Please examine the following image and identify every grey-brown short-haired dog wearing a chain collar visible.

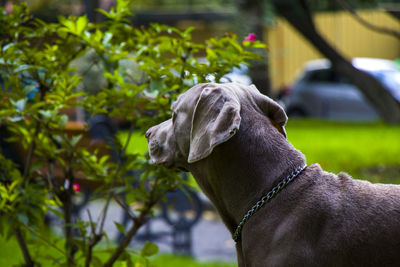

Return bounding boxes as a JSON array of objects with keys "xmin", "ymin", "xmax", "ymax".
[{"xmin": 146, "ymin": 83, "xmax": 400, "ymax": 267}]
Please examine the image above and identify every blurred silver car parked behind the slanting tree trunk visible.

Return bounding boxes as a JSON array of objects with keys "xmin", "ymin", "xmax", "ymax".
[{"xmin": 284, "ymin": 58, "xmax": 400, "ymax": 121}]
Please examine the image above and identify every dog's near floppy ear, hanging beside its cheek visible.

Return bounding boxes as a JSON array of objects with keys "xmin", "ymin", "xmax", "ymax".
[{"xmin": 188, "ymin": 87, "xmax": 241, "ymax": 163}]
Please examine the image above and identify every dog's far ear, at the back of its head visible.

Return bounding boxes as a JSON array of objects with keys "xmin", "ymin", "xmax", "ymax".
[{"xmin": 250, "ymin": 85, "xmax": 288, "ymax": 138}]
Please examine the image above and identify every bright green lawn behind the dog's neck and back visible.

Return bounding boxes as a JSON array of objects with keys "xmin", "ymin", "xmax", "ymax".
[{"xmin": 286, "ymin": 120, "xmax": 400, "ymax": 183}]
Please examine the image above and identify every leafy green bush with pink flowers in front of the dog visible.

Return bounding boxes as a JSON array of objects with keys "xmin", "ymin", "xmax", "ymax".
[{"xmin": 0, "ymin": 0, "xmax": 264, "ymax": 266}]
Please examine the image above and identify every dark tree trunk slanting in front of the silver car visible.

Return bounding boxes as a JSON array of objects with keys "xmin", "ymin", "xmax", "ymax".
[{"xmin": 273, "ymin": 0, "xmax": 400, "ymax": 124}]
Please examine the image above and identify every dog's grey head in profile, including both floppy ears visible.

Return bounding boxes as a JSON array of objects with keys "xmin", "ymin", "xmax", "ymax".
[{"xmin": 146, "ymin": 83, "xmax": 287, "ymax": 168}]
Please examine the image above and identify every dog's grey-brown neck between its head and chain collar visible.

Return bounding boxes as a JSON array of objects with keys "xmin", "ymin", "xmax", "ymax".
[{"xmin": 189, "ymin": 114, "xmax": 305, "ymax": 236}]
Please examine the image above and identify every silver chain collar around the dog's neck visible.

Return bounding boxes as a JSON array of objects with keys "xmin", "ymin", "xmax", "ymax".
[{"xmin": 232, "ymin": 165, "xmax": 307, "ymax": 242}]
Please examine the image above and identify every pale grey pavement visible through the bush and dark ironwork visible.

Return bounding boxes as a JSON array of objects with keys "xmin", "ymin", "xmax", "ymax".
[{"xmin": 81, "ymin": 201, "xmax": 236, "ymax": 262}]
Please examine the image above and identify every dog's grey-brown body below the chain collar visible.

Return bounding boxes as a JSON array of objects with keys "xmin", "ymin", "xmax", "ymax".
[{"xmin": 243, "ymin": 164, "xmax": 400, "ymax": 266}]
